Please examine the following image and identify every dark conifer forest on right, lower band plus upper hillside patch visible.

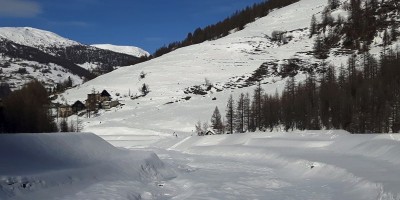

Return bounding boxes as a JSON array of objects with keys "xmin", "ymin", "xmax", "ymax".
[{"xmin": 203, "ymin": 0, "xmax": 400, "ymax": 135}]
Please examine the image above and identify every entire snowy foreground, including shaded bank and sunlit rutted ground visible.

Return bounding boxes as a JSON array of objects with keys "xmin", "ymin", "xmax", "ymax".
[{"xmin": 0, "ymin": 131, "xmax": 400, "ymax": 200}]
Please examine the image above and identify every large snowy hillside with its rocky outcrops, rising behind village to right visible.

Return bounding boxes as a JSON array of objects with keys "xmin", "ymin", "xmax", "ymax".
[{"xmin": 60, "ymin": 0, "xmax": 399, "ymax": 133}]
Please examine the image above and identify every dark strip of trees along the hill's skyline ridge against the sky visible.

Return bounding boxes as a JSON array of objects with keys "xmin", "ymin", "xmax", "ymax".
[{"xmin": 153, "ymin": 0, "xmax": 299, "ymax": 57}]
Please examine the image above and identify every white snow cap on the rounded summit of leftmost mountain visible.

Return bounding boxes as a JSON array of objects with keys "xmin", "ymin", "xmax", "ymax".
[{"xmin": 0, "ymin": 27, "xmax": 81, "ymax": 49}]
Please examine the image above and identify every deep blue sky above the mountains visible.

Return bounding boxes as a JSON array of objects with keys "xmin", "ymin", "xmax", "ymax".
[{"xmin": 0, "ymin": 0, "xmax": 263, "ymax": 53}]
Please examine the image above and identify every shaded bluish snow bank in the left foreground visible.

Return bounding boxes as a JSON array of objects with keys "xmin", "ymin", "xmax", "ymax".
[{"xmin": 0, "ymin": 133, "xmax": 174, "ymax": 199}]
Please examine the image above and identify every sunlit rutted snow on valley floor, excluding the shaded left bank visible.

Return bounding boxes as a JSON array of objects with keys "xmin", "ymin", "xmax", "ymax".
[{"xmin": 3, "ymin": 131, "xmax": 400, "ymax": 200}]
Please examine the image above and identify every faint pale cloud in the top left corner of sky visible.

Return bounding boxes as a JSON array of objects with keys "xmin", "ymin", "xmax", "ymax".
[{"xmin": 0, "ymin": 0, "xmax": 42, "ymax": 18}]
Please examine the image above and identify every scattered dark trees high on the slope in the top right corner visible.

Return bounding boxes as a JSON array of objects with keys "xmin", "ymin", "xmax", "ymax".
[{"xmin": 309, "ymin": 0, "xmax": 400, "ymax": 54}]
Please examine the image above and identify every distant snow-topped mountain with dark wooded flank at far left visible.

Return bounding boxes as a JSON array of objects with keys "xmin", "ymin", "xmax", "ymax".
[{"xmin": 0, "ymin": 27, "xmax": 143, "ymax": 88}]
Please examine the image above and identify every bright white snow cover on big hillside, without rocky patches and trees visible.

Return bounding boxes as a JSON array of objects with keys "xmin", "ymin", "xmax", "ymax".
[{"xmin": 54, "ymin": 0, "xmax": 330, "ymax": 134}]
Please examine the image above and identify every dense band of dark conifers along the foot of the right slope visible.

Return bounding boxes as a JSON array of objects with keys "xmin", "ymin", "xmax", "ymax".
[{"xmin": 200, "ymin": 50, "xmax": 400, "ymax": 135}]
